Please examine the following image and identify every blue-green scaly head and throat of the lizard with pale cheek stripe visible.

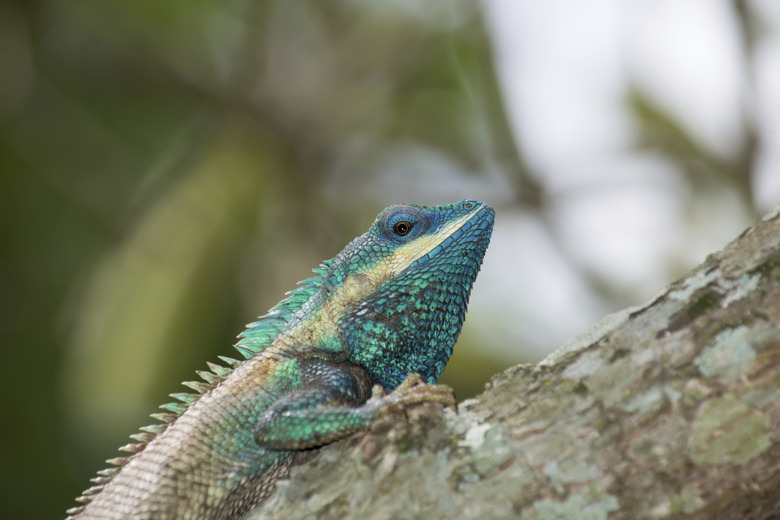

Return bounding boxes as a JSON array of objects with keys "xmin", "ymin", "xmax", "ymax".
[{"xmin": 334, "ymin": 200, "xmax": 495, "ymax": 390}]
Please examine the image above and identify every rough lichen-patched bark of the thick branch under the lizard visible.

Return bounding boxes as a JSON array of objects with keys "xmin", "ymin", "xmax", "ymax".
[{"xmin": 249, "ymin": 206, "xmax": 780, "ymax": 519}]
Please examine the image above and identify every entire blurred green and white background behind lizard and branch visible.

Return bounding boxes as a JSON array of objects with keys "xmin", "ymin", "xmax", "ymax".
[{"xmin": 0, "ymin": 0, "xmax": 780, "ymax": 519}]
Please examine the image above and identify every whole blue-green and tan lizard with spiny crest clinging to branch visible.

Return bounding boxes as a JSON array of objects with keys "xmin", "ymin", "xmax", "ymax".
[{"xmin": 67, "ymin": 200, "xmax": 495, "ymax": 520}]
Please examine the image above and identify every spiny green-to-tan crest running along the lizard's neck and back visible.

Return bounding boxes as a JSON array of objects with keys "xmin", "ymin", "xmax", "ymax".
[{"xmin": 66, "ymin": 260, "xmax": 333, "ymax": 520}]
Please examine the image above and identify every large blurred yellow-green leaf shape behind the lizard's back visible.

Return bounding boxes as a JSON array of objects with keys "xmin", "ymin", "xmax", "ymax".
[{"xmin": 65, "ymin": 119, "xmax": 279, "ymax": 480}]
